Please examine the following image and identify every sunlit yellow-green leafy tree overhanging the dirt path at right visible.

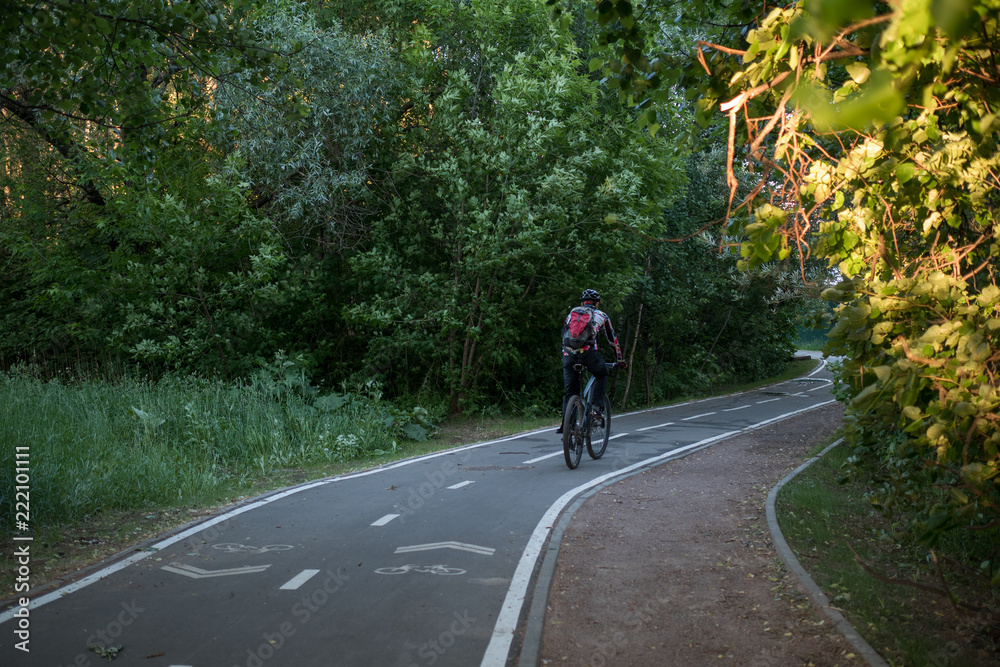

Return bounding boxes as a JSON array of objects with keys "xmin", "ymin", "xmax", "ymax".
[{"xmin": 572, "ymin": 0, "xmax": 1000, "ymax": 544}]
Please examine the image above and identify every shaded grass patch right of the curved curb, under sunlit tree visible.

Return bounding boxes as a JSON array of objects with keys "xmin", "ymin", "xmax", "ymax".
[{"xmin": 777, "ymin": 445, "xmax": 1000, "ymax": 667}]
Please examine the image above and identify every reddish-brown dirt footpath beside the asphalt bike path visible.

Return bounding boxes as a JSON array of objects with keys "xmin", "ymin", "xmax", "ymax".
[{"xmin": 539, "ymin": 404, "xmax": 864, "ymax": 667}]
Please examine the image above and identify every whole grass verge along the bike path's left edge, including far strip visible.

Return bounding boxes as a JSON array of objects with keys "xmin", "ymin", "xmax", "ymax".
[{"xmin": 0, "ymin": 360, "xmax": 816, "ymax": 599}]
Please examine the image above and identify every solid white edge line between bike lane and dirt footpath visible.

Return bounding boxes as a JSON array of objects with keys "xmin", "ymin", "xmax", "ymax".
[{"xmin": 480, "ymin": 399, "xmax": 836, "ymax": 667}]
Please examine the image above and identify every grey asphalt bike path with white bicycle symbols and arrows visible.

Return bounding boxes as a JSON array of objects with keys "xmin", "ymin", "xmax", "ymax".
[{"xmin": 0, "ymin": 360, "xmax": 833, "ymax": 667}]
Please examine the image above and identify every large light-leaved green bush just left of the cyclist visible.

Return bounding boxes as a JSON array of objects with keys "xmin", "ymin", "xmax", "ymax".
[{"xmin": 349, "ymin": 9, "xmax": 675, "ymax": 411}]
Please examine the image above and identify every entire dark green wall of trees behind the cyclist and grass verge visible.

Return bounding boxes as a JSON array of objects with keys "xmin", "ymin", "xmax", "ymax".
[{"xmin": 0, "ymin": 0, "xmax": 812, "ymax": 486}]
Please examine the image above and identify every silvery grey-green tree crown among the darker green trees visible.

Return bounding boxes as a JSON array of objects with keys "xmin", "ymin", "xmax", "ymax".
[{"xmin": 215, "ymin": 7, "xmax": 402, "ymax": 245}]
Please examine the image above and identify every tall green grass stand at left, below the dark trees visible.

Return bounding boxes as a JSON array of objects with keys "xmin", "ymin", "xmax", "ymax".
[{"xmin": 0, "ymin": 371, "xmax": 429, "ymax": 539}]
